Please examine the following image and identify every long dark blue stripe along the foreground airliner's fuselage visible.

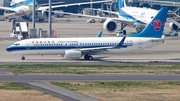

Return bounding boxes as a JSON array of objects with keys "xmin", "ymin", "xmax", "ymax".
[{"xmin": 6, "ymin": 44, "xmax": 133, "ymax": 52}]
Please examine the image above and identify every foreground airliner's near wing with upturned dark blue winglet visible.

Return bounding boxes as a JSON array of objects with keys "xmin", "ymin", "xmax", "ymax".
[{"xmin": 80, "ymin": 36, "xmax": 126, "ymax": 55}]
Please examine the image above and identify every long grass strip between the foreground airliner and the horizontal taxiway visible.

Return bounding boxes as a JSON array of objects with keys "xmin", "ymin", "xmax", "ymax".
[{"xmin": 0, "ymin": 64, "xmax": 180, "ymax": 74}]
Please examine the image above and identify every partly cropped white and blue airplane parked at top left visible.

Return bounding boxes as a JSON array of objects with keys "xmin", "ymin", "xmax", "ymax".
[{"xmin": 0, "ymin": 0, "xmax": 111, "ymax": 19}]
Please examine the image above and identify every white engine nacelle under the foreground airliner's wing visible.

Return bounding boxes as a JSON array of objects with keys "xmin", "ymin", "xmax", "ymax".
[{"xmin": 65, "ymin": 50, "xmax": 82, "ymax": 59}]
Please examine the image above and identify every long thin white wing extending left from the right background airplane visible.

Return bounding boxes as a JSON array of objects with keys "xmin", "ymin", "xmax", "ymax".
[{"xmin": 61, "ymin": 12, "xmax": 134, "ymax": 25}]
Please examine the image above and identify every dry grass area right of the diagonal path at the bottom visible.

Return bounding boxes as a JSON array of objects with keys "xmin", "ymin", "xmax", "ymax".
[{"xmin": 50, "ymin": 82, "xmax": 180, "ymax": 101}]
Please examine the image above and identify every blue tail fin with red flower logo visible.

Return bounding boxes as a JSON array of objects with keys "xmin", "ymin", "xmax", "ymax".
[{"xmin": 130, "ymin": 7, "xmax": 168, "ymax": 38}]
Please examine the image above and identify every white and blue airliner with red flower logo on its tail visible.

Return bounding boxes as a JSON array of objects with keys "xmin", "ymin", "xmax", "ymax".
[{"xmin": 6, "ymin": 7, "xmax": 168, "ymax": 60}]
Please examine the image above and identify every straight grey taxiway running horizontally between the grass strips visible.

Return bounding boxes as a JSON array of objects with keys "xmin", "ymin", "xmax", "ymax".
[{"xmin": 0, "ymin": 74, "xmax": 180, "ymax": 82}]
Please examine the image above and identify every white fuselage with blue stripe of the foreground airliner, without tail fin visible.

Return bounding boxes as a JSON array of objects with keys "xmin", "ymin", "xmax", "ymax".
[{"xmin": 6, "ymin": 37, "xmax": 162, "ymax": 56}]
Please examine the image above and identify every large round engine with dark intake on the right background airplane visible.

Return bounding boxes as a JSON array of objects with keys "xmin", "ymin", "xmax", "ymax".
[{"xmin": 103, "ymin": 19, "xmax": 117, "ymax": 33}]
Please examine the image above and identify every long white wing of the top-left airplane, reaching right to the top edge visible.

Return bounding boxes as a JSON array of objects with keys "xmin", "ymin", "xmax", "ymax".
[{"xmin": 37, "ymin": 0, "xmax": 112, "ymax": 10}]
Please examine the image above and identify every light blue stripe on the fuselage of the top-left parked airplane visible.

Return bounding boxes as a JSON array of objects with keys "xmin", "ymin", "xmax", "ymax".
[{"xmin": 11, "ymin": 0, "xmax": 38, "ymax": 9}]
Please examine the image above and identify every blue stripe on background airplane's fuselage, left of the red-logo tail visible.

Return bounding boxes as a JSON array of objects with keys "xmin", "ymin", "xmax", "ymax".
[{"xmin": 119, "ymin": 9, "xmax": 147, "ymax": 24}]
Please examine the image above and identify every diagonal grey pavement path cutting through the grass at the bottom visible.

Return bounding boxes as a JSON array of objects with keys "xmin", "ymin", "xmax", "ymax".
[{"xmin": 18, "ymin": 82, "xmax": 99, "ymax": 101}]
